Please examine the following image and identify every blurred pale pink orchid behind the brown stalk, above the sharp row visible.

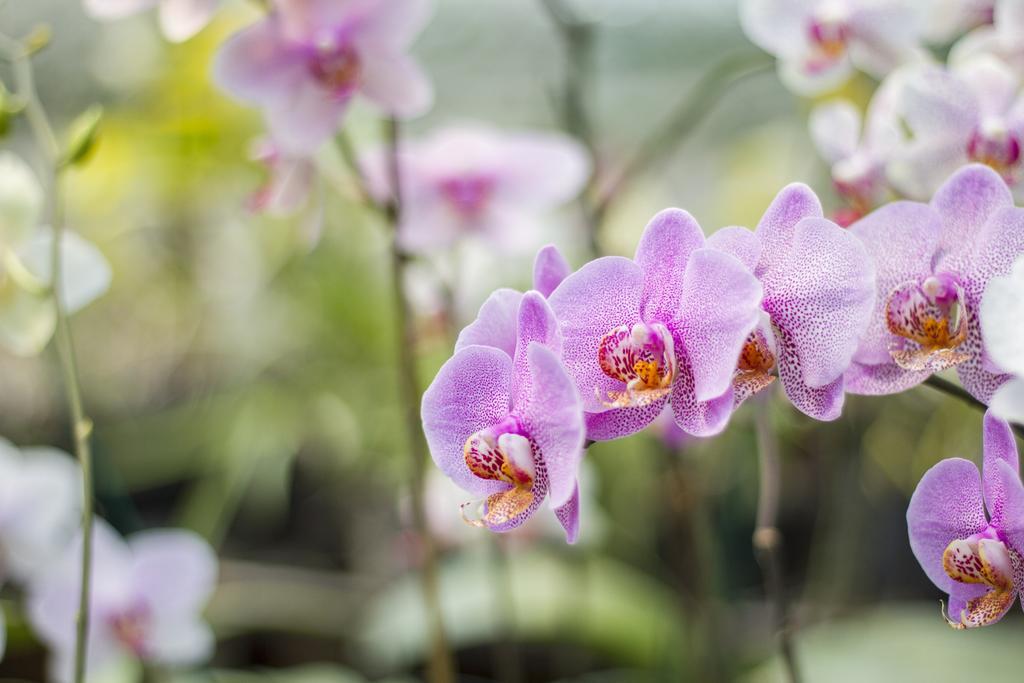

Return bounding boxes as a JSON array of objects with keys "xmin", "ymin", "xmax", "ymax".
[{"xmin": 361, "ymin": 124, "xmax": 590, "ymax": 251}]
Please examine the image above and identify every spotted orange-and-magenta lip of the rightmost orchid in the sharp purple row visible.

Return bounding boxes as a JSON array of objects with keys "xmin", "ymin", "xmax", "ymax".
[{"xmin": 886, "ymin": 273, "xmax": 970, "ymax": 372}]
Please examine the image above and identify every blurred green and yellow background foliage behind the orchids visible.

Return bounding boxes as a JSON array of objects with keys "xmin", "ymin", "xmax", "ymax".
[{"xmin": 0, "ymin": 0, "xmax": 1024, "ymax": 683}]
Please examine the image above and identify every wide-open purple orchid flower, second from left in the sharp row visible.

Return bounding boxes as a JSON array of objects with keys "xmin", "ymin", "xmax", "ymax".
[{"xmin": 550, "ymin": 209, "xmax": 761, "ymax": 440}]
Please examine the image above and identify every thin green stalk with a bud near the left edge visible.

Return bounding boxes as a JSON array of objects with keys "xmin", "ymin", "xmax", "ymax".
[{"xmin": 0, "ymin": 29, "xmax": 93, "ymax": 683}]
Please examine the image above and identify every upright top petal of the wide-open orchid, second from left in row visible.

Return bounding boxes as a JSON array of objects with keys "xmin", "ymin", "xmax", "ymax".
[{"xmin": 634, "ymin": 209, "xmax": 705, "ymax": 323}]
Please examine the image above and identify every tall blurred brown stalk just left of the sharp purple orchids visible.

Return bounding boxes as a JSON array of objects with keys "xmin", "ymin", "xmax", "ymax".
[{"xmin": 384, "ymin": 119, "xmax": 455, "ymax": 683}]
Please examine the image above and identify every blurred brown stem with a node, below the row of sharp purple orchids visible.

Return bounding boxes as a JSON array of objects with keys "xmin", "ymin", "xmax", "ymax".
[{"xmin": 753, "ymin": 398, "xmax": 801, "ymax": 683}]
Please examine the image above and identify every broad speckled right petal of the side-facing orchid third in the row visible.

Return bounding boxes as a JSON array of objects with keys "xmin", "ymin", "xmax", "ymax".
[{"xmin": 758, "ymin": 218, "xmax": 874, "ymax": 393}]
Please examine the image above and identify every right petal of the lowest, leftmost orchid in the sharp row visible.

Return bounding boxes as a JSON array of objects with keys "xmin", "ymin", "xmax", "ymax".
[{"xmin": 517, "ymin": 342, "xmax": 586, "ymax": 508}]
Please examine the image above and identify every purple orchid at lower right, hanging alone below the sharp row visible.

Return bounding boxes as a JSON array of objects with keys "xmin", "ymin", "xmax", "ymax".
[{"xmin": 906, "ymin": 414, "xmax": 1024, "ymax": 629}]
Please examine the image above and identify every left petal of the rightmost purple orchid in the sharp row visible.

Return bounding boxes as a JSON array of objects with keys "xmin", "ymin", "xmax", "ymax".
[{"xmin": 849, "ymin": 202, "xmax": 942, "ymax": 365}]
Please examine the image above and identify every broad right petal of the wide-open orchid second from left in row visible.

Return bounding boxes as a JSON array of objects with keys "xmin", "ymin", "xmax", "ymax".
[{"xmin": 679, "ymin": 248, "xmax": 762, "ymax": 401}]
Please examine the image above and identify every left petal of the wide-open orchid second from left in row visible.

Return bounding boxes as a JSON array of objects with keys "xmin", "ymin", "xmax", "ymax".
[{"xmin": 548, "ymin": 256, "xmax": 643, "ymax": 413}]
